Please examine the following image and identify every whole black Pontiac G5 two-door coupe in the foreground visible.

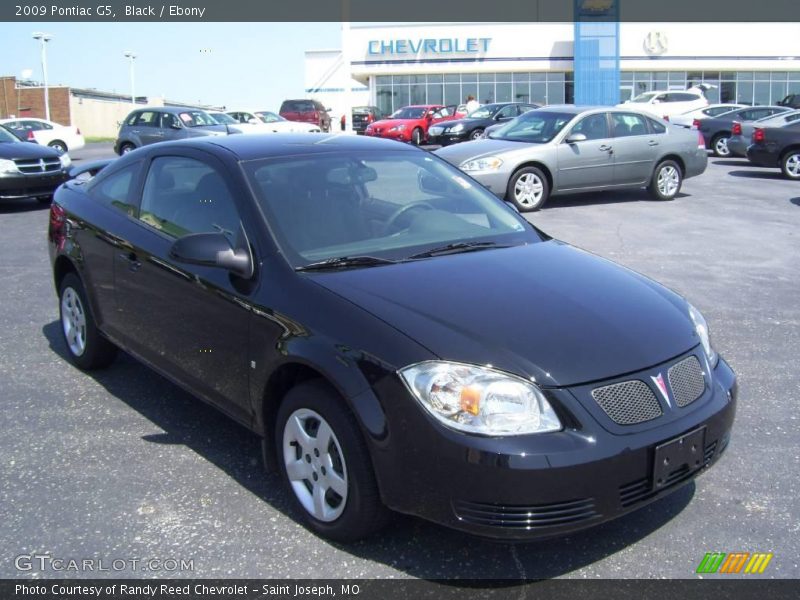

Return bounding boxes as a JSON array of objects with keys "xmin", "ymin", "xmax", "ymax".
[{"xmin": 49, "ymin": 135, "xmax": 736, "ymax": 541}]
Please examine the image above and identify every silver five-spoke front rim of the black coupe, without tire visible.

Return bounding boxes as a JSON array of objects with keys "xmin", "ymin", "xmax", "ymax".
[{"xmin": 283, "ymin": 408, "xmax": 347, "ymax": 522}]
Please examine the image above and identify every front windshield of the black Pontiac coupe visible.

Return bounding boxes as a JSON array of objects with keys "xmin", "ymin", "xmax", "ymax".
[{"xmin": 243, "ymin": 150, "xmax": 541, "ymax": 268}]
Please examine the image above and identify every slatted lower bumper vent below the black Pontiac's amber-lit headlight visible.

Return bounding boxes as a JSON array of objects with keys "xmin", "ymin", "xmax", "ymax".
[{"xmin": 453, "ymin": 498, "xmax": 599, "ymax": 529}]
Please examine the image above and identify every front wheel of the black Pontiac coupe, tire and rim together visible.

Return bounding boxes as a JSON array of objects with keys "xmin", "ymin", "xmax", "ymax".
[{"xmin": 275, "ymin": 381, "xmax": 388, "ymax": 542}]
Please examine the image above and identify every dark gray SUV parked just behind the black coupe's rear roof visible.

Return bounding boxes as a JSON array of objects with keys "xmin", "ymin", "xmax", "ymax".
[{"xmin": 114, "ymin": 106, "xmax": 234, "ymax": 155}]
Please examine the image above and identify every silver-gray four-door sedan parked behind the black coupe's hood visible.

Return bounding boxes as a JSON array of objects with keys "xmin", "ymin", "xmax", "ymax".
[{"xmin": 436, "ymin": 105, "xmax": 708, "ymax": 211}]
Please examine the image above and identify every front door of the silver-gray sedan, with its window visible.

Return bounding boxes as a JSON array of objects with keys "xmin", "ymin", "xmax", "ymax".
[{"xmin": 554, "ymin": 112, "xmax": 614, "ymax": 191}]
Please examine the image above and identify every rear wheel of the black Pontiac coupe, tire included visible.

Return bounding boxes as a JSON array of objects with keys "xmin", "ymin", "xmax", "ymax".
[{"xmin": 58, "ymin": 273, "xmax": 117, "ymax": 370}]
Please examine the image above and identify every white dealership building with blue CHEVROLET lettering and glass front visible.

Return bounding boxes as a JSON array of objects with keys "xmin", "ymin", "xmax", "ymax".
[{"xmin": 305, "ymin": 23, "xmax": 800, "ymax": 118}]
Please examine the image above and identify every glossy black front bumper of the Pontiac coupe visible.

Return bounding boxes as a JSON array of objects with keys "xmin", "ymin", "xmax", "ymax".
[{"xmin": 373, "ymin": 353, "xmax": 737, "ymax": 539}]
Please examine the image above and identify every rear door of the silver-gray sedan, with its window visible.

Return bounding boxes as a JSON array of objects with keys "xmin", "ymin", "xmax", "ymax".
[{"xmin": 611, "ymin": 112, "xmax": 664, "ymax": 185}]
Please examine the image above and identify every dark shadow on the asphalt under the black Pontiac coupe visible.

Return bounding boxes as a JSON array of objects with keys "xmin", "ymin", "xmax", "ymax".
[{"xmin": 42, "ymin": 321, "xmax": 695, "ymax": 587}]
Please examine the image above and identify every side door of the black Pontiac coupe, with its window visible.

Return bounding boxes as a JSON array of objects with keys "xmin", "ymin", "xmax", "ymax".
[{"xmin": 114, "ymin": 148, "xmax": 253, "ymax": 421}]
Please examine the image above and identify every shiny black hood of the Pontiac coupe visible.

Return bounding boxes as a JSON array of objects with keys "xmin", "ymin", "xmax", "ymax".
[{"xmin": 311, "ymin": 241, "xmax": 699, "ymax": 386}]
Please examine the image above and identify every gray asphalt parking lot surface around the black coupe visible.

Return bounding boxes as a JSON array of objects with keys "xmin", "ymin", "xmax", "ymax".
[{"xmin": 0, "ymin": 144, "xmax": 800, "ymax": 579}]
